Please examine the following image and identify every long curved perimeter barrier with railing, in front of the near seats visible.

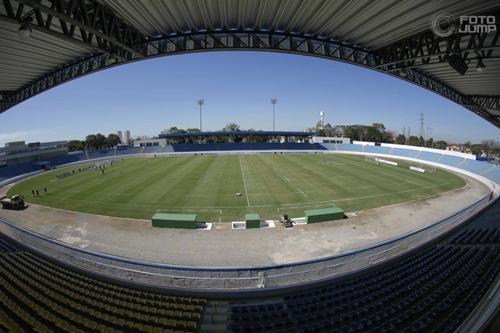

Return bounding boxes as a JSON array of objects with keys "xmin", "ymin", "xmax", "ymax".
[{"xmin": 0, "ymin": 191, "xmax": 492, "ymax": 294}]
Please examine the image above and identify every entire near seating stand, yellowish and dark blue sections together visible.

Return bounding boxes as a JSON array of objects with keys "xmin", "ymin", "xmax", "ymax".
[{"xmin": 0, "ymin": 197, "xmax": 500, "ymax": 333}]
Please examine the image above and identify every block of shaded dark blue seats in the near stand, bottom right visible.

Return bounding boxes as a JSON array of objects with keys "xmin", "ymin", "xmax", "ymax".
[{"xmin": 229, "ymin": 197, "xmax": 500, "ymax": 332}]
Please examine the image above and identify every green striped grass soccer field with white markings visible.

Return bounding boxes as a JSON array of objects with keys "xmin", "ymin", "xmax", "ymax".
[{"xmin": 9, "ymin": 154, "xmax": 465, "ymax": 221}]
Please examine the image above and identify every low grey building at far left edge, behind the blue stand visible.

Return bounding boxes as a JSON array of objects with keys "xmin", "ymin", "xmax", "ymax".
[{"xmin": 0, "ymin": 141, "xmax": 68, "ymax": 165}]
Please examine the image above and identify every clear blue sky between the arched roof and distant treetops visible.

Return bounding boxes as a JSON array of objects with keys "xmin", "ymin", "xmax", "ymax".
[{"xmin": 0, "ymin": 51, "xmax": 500, "ymax": 145}]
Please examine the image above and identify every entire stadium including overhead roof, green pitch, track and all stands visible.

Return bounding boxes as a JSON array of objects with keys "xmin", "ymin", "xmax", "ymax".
[{"xmin": 0, "ymin": 0, "xmax": 500, "ymax": 333}]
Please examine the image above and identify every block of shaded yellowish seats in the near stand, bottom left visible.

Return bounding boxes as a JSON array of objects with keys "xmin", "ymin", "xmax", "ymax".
[{"xmin": 0, "ymin": 235, "xmax": 206, "ymax": 333}]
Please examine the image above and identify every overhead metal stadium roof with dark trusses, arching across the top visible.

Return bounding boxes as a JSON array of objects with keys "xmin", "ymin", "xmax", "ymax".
[{"xmin": 0, "ymin": 0, "xmax": 500, "ymax": 127}]
